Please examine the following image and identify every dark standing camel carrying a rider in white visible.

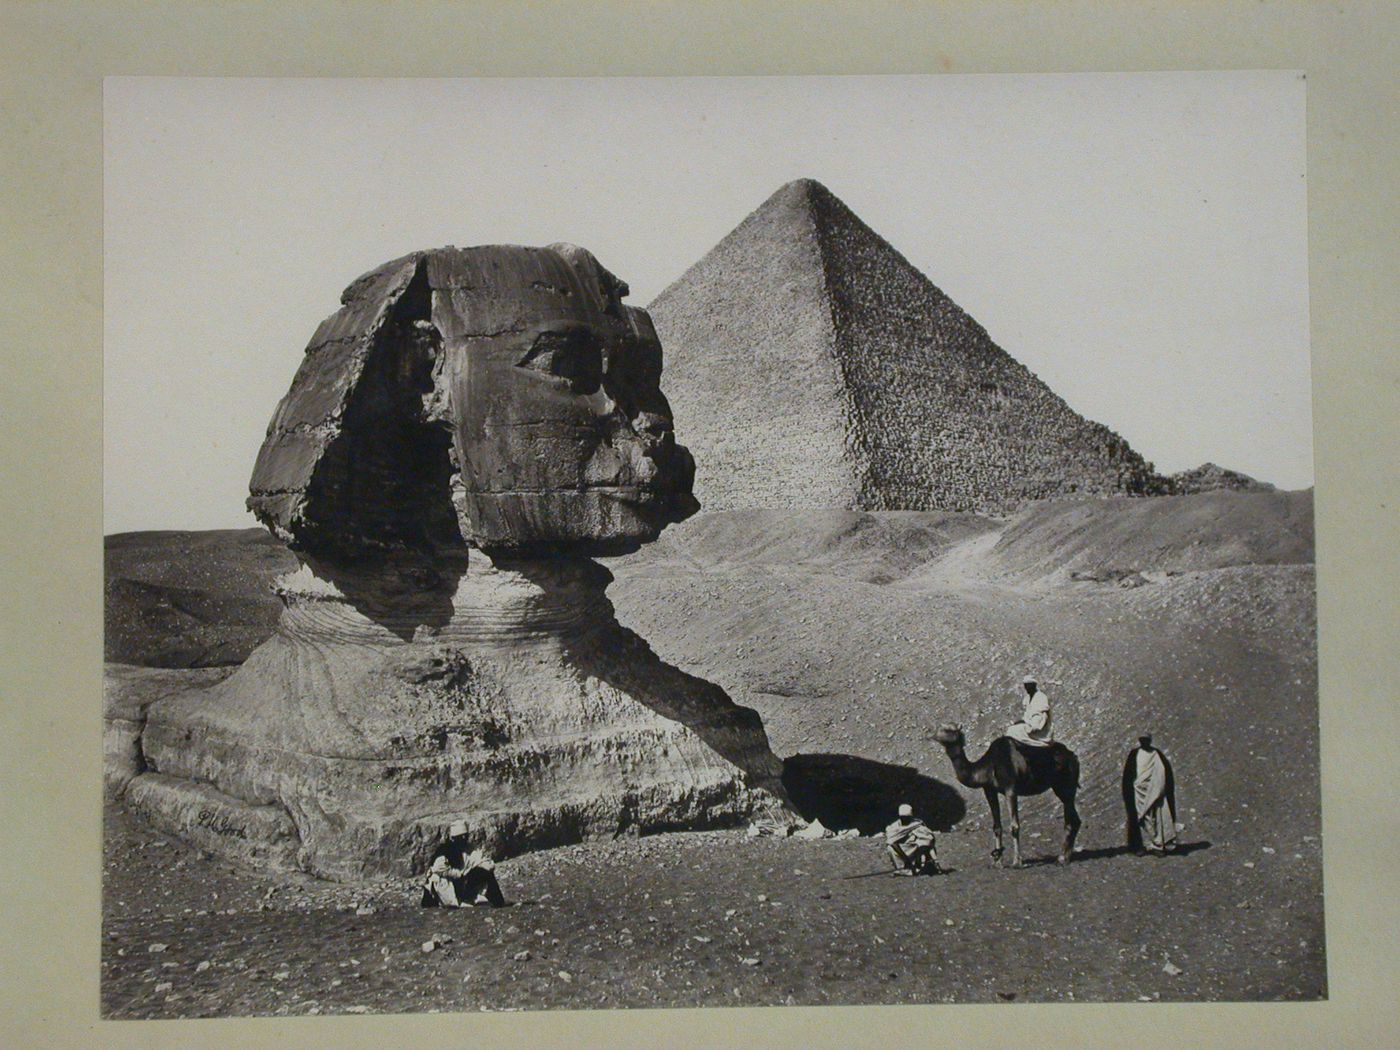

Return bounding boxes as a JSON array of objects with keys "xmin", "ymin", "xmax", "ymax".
[{"xmin": 934, "ymin": 725, "xmax": 1079, "ymax": 868}]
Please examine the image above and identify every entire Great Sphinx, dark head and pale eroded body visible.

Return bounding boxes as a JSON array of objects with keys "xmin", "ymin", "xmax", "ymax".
[{"xmin": 109, "ymin": 244, "xmax": 788, "ymax": 879}]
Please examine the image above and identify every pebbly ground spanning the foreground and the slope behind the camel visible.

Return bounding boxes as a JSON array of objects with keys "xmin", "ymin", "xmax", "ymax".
[{"xmin": 102, "ymin": 493, "xmax": 1326, "ymax": 1016}]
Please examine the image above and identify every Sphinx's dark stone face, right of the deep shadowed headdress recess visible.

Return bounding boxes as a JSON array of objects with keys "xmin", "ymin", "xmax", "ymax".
[{"xmin": 428, "ymin": 245, "xmax": 699, "ymax": 553}]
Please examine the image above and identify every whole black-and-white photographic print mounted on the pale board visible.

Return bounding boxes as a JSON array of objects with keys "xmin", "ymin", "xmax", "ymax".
[{"xmin": 94, "ymin": 70, "xmax": 1327, "ymax": 1019}]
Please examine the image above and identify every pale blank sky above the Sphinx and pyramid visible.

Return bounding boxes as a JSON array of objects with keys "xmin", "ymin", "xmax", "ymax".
[{"xmin": 104, "ymin": 71, "xmax": 1313, "ymax": 532}]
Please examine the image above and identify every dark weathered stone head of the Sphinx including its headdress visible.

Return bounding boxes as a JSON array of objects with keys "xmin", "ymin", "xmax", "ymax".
[{"xmin": 248, "ymin": 245, "xmax": 699, "ymax": 561}]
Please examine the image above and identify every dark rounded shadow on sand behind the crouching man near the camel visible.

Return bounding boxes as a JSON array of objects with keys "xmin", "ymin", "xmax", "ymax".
[{"xmin": 783, "ymin": 755, "xmax": 966, "ymax": 834}]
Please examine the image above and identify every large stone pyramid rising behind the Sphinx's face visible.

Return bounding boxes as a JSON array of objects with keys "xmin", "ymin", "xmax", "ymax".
[{"xmin": 648, "ymin": 179, "xmax": 1162, "ymax": 512}]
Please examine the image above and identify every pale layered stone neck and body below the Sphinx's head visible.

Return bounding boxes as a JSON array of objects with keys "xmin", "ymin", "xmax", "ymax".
[{"xmin": 127, "ymin": 557, "xmax": 783, "ymax": 879}]
